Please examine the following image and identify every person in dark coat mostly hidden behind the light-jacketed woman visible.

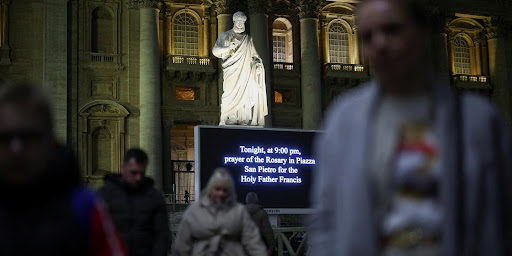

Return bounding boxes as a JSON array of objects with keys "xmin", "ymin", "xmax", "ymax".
[{"xmin": 245, "ymin": 192, "xmax": 276, "ymax": 255}]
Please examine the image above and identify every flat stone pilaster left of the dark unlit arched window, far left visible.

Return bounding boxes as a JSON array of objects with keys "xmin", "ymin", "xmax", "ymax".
[{"xmin": 43, "ymin": 0, "xmax": 68, "ymax": 143}]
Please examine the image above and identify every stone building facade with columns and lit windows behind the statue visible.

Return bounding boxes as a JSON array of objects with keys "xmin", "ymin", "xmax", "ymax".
[{"xmin": 0, "ymin": 0, "xmax": 512, "ymax": 194}]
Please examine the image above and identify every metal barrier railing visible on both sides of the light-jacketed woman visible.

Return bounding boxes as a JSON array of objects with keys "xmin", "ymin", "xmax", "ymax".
[{"xmin": 171, "ymin": 227, "xmax": 310, "ymax": 256}]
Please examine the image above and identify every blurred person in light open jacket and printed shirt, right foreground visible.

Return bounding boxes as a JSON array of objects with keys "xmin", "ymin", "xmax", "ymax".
[{"xmin": 310, "ymin": 0, "xmax": 512, "ymax": 256}]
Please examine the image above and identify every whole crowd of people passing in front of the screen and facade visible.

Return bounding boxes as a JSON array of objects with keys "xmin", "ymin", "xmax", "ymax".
[{"xmin": 0, "ymin": 0, "xmax": 512, "ymax": 256}]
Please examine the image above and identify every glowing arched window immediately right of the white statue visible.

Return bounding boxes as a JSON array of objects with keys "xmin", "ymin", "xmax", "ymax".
[{"xmin": 272, "ymin": 18, "xmax": 293, "ymax": 63}]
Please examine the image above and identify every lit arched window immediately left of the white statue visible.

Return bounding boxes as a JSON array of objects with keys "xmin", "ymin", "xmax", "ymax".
[{"xmin": 173, "ymin": 13, "xmax": 199, "ymax": 56}]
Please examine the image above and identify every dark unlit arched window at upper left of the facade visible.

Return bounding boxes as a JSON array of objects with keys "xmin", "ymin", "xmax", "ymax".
[{"xmin": 91, "ymin": 7, "xmax": 114, "ymax": 53}]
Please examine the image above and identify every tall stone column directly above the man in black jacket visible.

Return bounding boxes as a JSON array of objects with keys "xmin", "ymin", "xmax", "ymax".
[{"xmin": 139, "ymin": 0, "xmax": 163, "ymax": 189}]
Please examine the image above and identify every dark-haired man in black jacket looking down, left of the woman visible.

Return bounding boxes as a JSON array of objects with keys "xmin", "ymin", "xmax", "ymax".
[{"xmin": 99, "ymin": 148, "xmax": 170, "ymax": 256}]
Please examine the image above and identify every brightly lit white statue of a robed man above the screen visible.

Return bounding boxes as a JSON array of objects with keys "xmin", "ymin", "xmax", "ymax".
[{"xmin": 213, "ymin": 12, "xmax": 268, "ymax": 126}]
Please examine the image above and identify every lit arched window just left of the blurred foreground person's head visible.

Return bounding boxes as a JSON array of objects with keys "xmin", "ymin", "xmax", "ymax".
[{"xmin": 329, "ymin": 22, "xmax": 349, "ymax": 64}]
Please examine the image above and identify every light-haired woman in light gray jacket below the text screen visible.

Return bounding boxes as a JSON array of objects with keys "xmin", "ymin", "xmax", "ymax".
[{"xmin": 174, "ymin": 168, "xmax": 267, "ymax": 256}]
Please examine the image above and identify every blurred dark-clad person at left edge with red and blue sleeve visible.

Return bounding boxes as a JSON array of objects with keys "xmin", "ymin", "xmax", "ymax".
[{"xmin": 0, "ymin": 83, "xmax": 126, "ymax": 256}]
